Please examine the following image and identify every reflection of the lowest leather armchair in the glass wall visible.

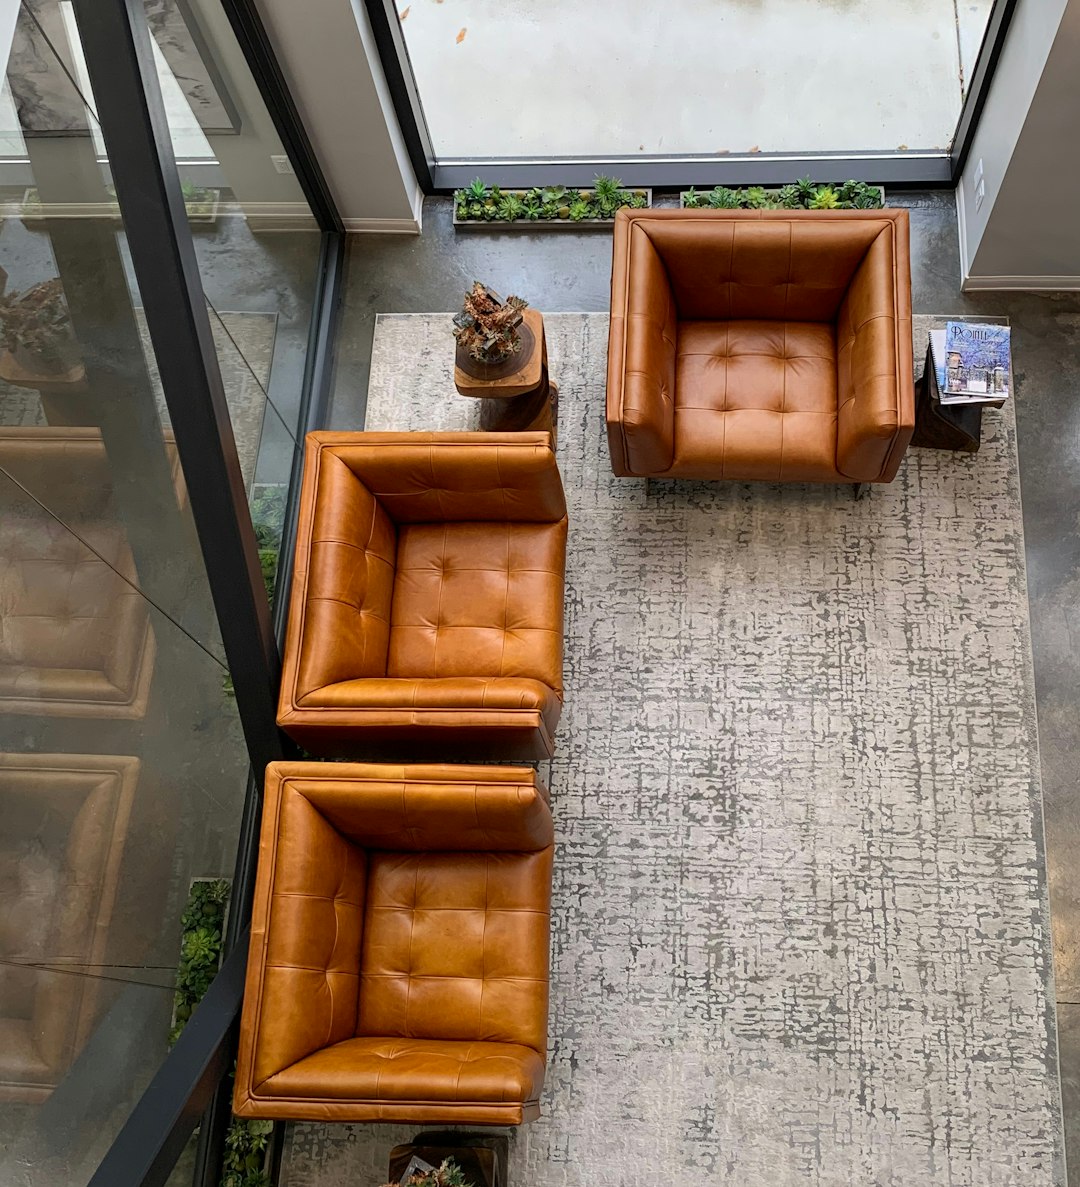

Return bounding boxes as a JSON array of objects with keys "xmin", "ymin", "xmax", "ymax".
[{"xmin": 0, "ymin": 754, "xmax": 139, "ymax": 1102}]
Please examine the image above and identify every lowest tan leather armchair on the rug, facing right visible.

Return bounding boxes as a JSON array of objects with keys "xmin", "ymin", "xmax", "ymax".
[{"xmin": 234, "ymin": 763, "xmax": 553, "ymax": 1125}]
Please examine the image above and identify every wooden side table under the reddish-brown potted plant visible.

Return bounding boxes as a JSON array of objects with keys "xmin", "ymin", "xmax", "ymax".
[{"xmin": 453, "ymin": 309, "xmax": 559, "ymax": 440}]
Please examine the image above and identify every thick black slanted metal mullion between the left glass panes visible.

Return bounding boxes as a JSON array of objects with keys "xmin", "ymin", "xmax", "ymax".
[{"xmin": 74, "ymin": 0, "xmax": 293, "ymax": 773}]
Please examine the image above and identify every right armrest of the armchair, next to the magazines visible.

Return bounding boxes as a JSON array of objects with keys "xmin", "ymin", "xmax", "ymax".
[{"xmin": 837, "ymin": 211, "xmax": 915, "ymax": 482}]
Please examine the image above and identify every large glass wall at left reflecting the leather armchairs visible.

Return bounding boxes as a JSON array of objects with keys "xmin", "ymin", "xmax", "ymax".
[{"xmin": 0, "ymin": 0, "xmax": 319, "ymax": 1187}]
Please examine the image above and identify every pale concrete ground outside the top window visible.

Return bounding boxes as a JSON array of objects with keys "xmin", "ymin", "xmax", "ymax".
[{"xmin": 398, "ymin": 0, "xmax": 991, "ymax": 159}]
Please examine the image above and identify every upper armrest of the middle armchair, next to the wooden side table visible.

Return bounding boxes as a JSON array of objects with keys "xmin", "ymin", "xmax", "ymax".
[{"xmin": 309, "ymin": 432, "xmax": 566, "ymax": 523}]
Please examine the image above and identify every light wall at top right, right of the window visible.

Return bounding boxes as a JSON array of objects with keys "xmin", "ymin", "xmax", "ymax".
[{"xmin": 957, "ymin": 0, "xmax": 1080, "ymax": 290}]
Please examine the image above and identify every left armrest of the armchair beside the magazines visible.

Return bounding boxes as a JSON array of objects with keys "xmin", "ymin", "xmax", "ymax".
[{"xmin": 606, "ymin": 211, "xmax": 678, "ymax": 476}]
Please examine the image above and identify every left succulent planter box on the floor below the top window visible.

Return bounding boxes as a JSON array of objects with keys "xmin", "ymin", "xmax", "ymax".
[{"xmin": 453, "ymin": 176, "xmax": 653, "ymax": 230}]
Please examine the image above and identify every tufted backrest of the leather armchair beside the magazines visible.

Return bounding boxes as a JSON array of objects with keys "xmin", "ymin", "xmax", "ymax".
[{"xmin": 634, "ymin": 211, "xmax": 889, "ymax": 322}]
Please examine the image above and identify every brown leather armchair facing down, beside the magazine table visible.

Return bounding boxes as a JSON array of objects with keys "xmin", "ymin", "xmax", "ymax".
[{"xmin": 608, "ymin": 210, "xmax": 915, "ymax": 483}]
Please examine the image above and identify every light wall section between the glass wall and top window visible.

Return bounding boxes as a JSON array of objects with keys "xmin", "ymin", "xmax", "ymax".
[{"xmin": 258, "ymin": 0, "xmax": 423, "ymax": 231}]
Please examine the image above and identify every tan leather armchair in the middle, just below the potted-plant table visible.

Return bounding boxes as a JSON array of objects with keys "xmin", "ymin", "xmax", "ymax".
[{"xmin": 278, "ymin": 432, "xmax": 566, "ymax": 758}]
